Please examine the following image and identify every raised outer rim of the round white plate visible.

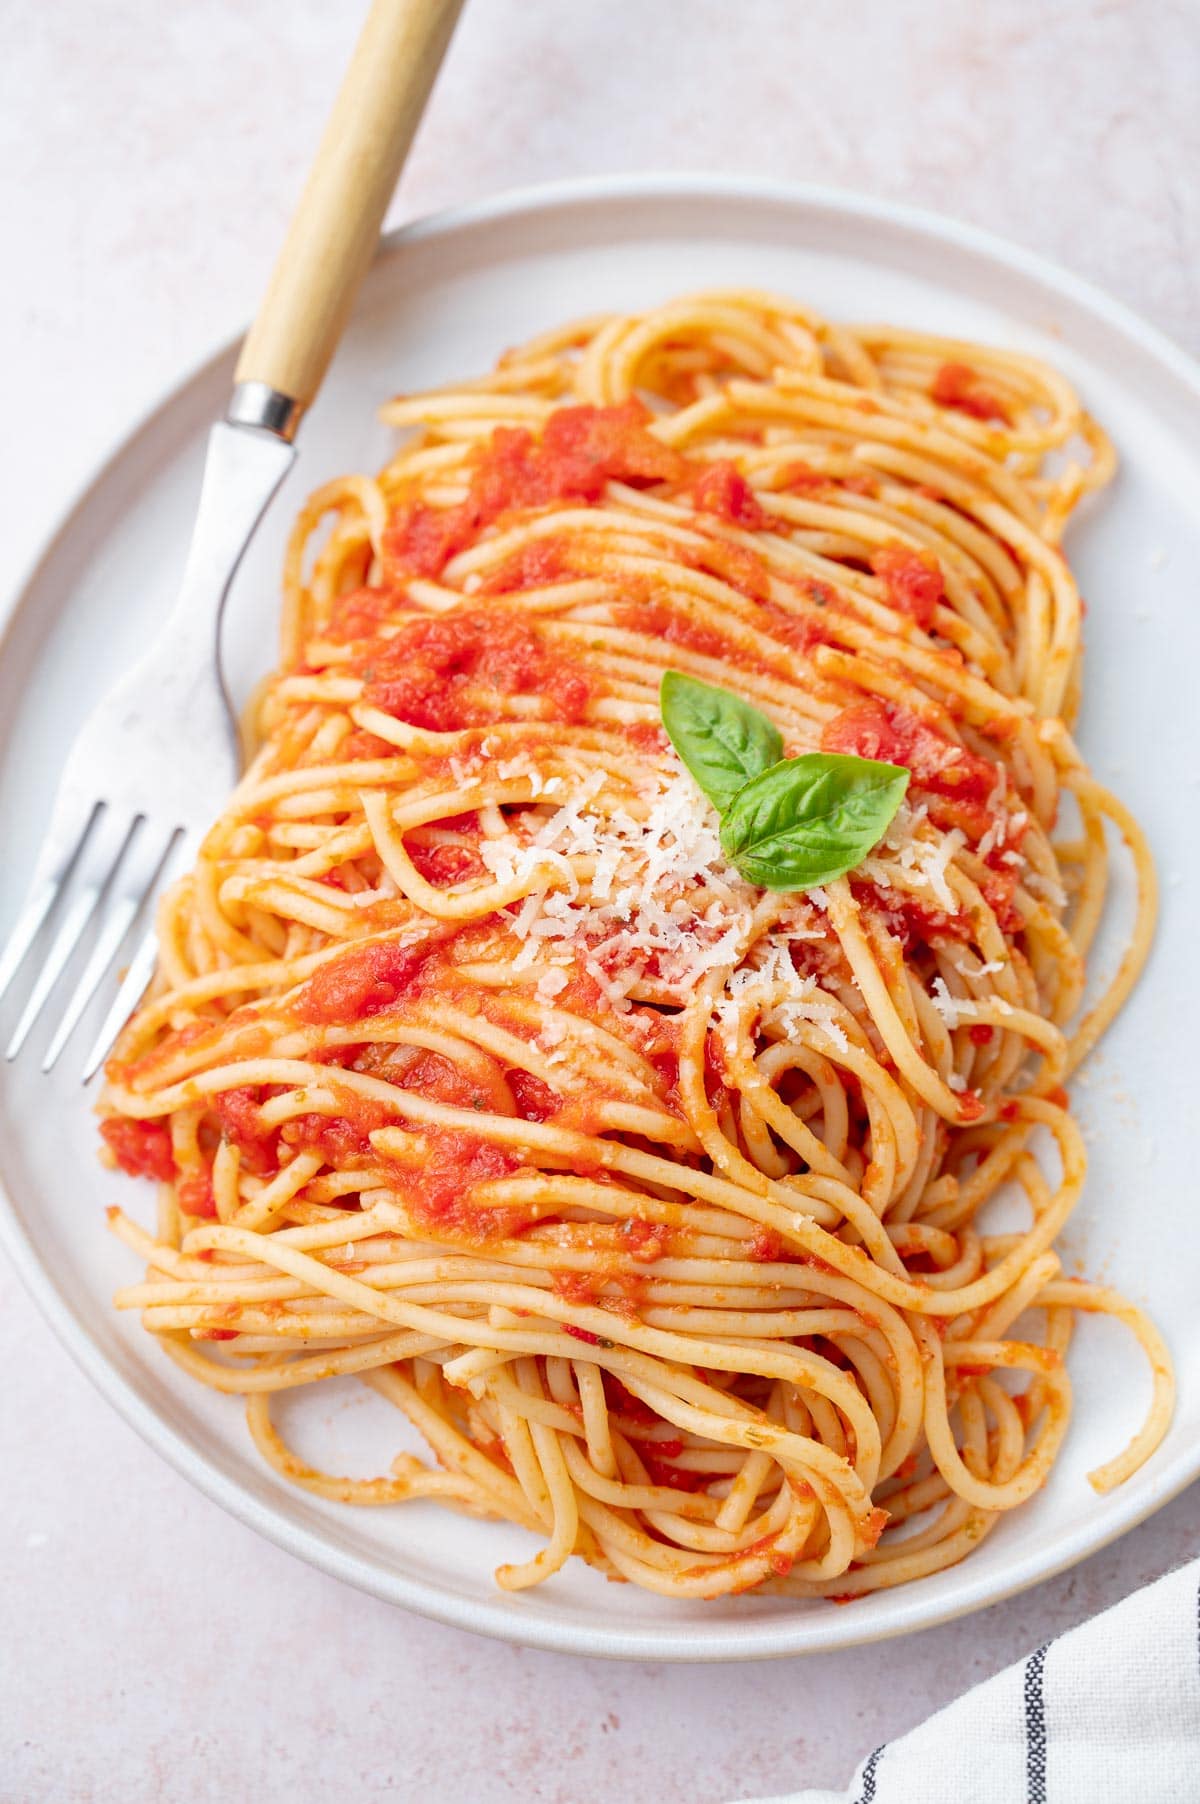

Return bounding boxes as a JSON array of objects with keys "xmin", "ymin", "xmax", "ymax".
[{"xmin": 0, "ymin": 171, "xmax": 1200, "ymax": 1663}]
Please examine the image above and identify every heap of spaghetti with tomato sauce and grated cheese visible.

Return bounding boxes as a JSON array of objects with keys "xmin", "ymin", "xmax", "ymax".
[{"xmin": 101, "ymin": 290, "xmax": 1171, "ymax": 1598}]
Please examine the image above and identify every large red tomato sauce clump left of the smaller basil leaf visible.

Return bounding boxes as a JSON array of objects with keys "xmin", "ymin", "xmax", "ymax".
[{"xmin": 361, "ymin": 608, "xmax": 597, "ymax": 732}]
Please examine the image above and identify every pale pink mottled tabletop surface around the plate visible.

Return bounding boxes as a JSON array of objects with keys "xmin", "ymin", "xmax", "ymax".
[{"xmin": 0, "ymin": 0, "xmax": 1200, "ymax": 1804}]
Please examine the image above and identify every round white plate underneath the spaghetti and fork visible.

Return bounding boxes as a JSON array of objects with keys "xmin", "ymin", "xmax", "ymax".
[{"xmin": 0, "ymin": 179, "xmax": 1200, "ymax": 1660}]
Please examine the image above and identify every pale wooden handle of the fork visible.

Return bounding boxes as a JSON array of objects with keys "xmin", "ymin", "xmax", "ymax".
[{"xmin": 235, "ymin": 0, "xmax": 464, "ymax": 422}]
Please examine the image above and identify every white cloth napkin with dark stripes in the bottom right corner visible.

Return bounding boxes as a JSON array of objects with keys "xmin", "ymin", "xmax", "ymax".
[{"xmin": 729, "ymin": 1560, "xmax": 1200, "ymax": 1804}]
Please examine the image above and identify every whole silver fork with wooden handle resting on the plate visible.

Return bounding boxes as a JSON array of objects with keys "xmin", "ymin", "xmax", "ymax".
[{"xmin": 0, "ymin": 0, "xmax": 464, "ymax": 1082}]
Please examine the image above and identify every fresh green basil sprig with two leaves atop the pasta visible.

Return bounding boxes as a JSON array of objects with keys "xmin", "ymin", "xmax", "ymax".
[{"xmin": 662, "ymin": 671, "xmax": 909, "ymax": 891}]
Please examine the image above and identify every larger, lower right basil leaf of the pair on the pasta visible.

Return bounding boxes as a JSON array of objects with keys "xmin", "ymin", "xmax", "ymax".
[{"xmin": 720, "ymin": 752, "xmax": 909, "ymax": 889}]
